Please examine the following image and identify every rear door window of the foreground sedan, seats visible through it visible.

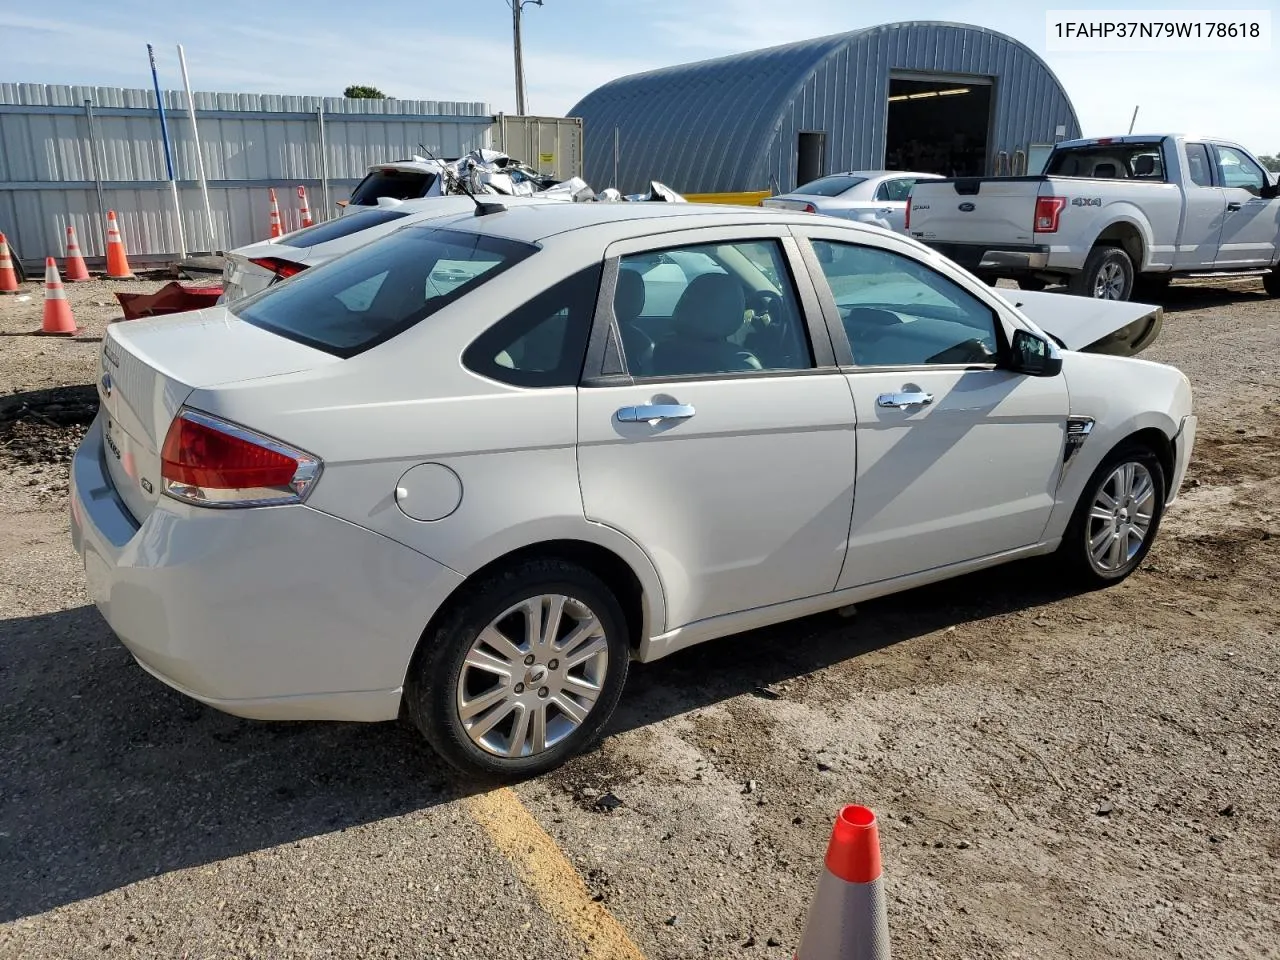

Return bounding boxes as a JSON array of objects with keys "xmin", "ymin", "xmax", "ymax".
[{"xmin": 613, "ymin": 239, "xmax": 813, "ymax": 378}]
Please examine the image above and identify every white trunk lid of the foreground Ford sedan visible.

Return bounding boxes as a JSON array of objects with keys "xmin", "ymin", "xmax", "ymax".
[{"xmin": 97, "ymin": 307, "xmax": 342, "ymax": 524}]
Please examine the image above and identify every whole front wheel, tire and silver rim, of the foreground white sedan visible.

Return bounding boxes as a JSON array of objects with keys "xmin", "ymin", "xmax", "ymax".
[{"xmin": 1059, "ymin": 443, "xmax": 1166, "ymax": 586}]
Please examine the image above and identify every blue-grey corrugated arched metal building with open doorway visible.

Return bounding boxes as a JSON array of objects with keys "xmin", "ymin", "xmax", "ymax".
[{"xmin": 568, "ymin": 22, "xmax": 1080, "ymax": 193}]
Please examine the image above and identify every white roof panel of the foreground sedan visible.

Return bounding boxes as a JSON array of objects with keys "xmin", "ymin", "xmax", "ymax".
[{"xmin": 404, "ymin": 197, "xmax": 881, "ymax": 243}]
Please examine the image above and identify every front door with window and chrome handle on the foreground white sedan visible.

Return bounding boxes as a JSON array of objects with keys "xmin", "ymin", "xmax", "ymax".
[{"xmin": 804, "ymin": 228, "xmax": 1068, "ymax": 589}]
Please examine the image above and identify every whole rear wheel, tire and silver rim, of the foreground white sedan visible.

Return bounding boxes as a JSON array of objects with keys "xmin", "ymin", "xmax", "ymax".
[{"xmin": 404, "ymin": 559, "xmax": 630, "ymax": 780}]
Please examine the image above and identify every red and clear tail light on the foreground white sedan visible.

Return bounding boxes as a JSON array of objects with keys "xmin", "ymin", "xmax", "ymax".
[{"xmin": 160, "ymin": 408, "xmax": 321, "ymax": 507}]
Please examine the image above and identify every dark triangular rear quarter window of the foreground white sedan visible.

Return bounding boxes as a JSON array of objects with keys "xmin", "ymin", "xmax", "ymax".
[{"xmin": 462, "ymin": 264, "xmax": 602, "ymax": 387}]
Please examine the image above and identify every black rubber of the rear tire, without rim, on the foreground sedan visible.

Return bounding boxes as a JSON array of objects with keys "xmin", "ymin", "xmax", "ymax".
[{"xmin": 404, "ymin": 559, "xmax": 631, "ymax": 780}]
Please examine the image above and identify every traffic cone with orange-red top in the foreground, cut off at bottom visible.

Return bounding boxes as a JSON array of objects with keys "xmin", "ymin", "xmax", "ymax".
[{"xmin": 795, "ymin": 806, "xmax": 890, "ymax": 960}]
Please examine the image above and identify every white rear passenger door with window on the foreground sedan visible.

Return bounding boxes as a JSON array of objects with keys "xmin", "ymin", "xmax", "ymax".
[{"xmin": 579, "ymin": 225, "xmax": 855, "ymax": 630}]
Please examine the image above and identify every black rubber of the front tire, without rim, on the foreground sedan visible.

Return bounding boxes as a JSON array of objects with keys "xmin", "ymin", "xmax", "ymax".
[{"xmin": 1057, "ymin": 443, "xmax": 1167, "ymax": 586}]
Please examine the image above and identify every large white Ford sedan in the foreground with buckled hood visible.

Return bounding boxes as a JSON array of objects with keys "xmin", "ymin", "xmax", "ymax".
[{"xmin": 70, "ymin": 204, "xmax": 1196, "ymax": 776}]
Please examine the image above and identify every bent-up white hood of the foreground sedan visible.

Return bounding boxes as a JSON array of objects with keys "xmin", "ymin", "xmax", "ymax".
[{"xmin": 992, "ymin": 288, "xmax": 1165, "ymax": 357}]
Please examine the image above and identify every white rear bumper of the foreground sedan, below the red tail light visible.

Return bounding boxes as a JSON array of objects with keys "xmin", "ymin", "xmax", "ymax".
[{"xmin": 70, "ymin": 421, "xmax": 461, "ymax": 721}]
